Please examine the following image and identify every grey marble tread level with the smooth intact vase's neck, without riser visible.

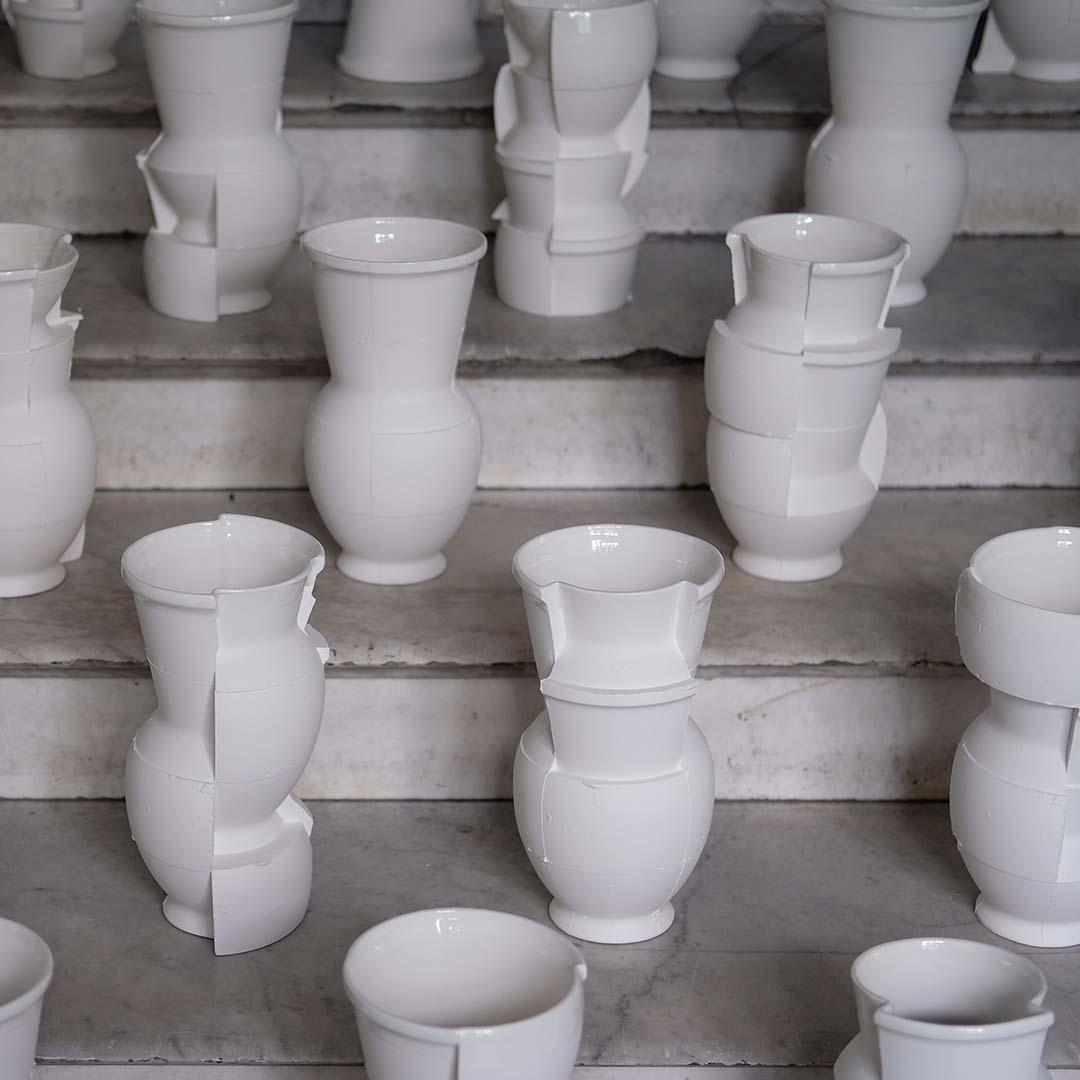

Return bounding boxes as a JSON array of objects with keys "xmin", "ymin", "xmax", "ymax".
[{"xmin": 64, "ymin": 238, "xmax": 1080, "ymax": 378}]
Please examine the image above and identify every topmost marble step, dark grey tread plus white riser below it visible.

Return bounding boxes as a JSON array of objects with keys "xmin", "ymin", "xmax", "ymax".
[{"xmin": 0, "ymin": 23, "xmax": 1080, "ymax": 234}]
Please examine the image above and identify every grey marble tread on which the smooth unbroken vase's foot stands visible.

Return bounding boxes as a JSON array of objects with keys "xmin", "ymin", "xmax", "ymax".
[{"xmin": 0, "ymin": 490, "xmax": 1080, "ymax": 675}]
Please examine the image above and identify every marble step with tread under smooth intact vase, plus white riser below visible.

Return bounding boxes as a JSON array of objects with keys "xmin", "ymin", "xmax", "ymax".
[{"xmin": 8, "ymin": 489, "xmax": 1080, "ymax": 799}]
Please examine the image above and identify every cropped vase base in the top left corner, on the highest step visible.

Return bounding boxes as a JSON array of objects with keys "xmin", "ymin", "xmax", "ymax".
[{"xmin": 3, "ymin": 0, "xmax": 133, "ymax": 79}]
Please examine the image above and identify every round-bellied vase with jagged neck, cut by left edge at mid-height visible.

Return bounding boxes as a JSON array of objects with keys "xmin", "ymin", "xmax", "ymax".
[{"xmin": 0, "ymin": 225, "xmax": 97, "ymax": 597}]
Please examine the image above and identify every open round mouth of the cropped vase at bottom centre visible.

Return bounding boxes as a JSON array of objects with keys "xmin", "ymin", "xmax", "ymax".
[{"xmin": 343, "ymin": 908, "xmax": 585, "ymax": 1042}]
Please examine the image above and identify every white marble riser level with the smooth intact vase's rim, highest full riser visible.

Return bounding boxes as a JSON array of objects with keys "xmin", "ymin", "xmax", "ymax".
[{"xmin": 4, "ymin": 126, "xmax": 1080, "ymax": 234}]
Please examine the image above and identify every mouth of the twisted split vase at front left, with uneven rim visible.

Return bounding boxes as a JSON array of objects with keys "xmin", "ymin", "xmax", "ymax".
[{"xmin": 121, "ymin": 514, "xmax": 324, "ymax": 606}]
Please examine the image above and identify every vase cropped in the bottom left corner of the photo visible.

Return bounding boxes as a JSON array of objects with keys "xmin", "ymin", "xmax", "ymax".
[{"xmin": 0, "ymin": 919, "xmax": 53, "ymax": 1080}]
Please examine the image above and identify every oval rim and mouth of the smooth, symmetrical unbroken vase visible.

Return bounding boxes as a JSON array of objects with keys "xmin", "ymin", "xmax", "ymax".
[{"xmin": 300, "ymin": 217, "xmax": 487, "ymax": 274}]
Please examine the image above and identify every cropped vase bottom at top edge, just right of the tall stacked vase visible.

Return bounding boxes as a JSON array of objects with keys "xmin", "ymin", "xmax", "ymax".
[{"xmin": 656, "ymin": 0, "xmax": 762, "ymax": 80}]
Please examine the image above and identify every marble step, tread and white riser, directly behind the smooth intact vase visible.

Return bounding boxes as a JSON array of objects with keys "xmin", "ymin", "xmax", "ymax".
[{"xmin": 65, "ymin": 238, "xmax": 1080, "ymax": 488}]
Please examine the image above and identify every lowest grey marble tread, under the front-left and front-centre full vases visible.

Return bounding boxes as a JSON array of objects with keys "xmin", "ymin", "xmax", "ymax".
[{"xmin": 6, "ymin": 801, "xmax": 1080, "ymax": 1067}]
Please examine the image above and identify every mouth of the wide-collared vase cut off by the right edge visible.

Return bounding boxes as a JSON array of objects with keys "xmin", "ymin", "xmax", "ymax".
[{"xmin": 969, "ymin": 525, "xmax": 1080, "ymax": 616}]
